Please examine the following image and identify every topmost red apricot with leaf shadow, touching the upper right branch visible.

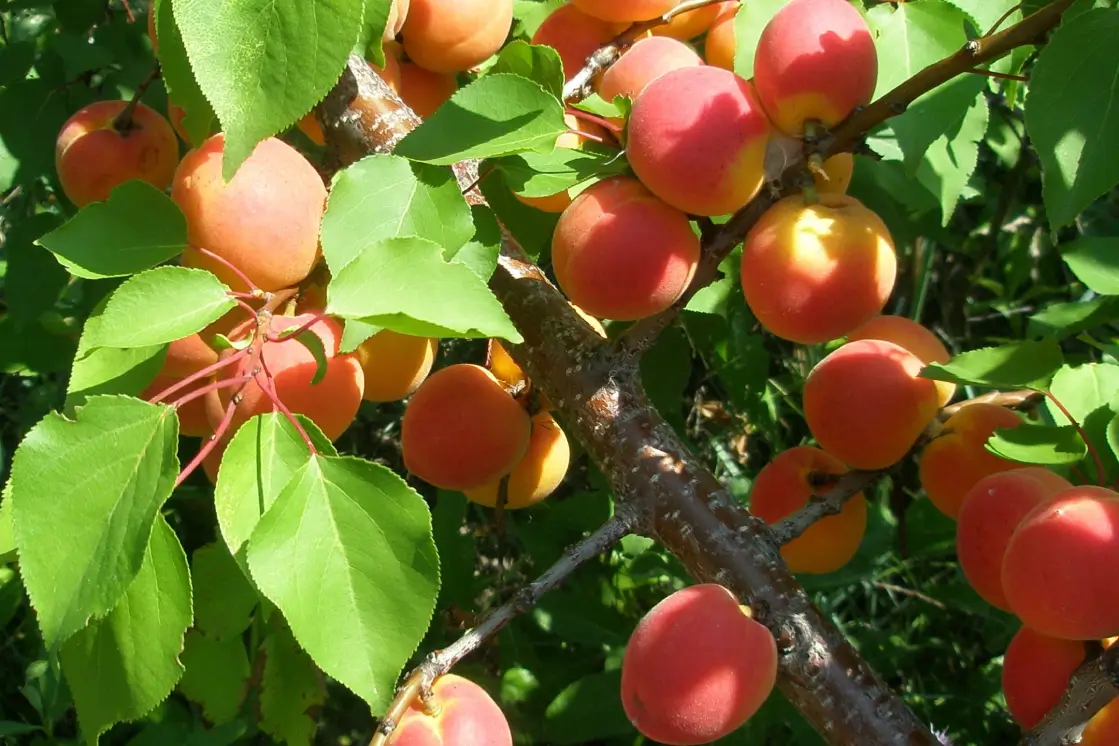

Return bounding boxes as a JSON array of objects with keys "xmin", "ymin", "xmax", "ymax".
[{"xmin": 754, "ymin": 0, "xmax": 878, "ymax": 136}]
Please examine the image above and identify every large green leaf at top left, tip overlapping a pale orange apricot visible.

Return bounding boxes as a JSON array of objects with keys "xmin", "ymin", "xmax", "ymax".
[{"xmin": 172, "ymin": 0, "xmax": 364, "ymax": 180}]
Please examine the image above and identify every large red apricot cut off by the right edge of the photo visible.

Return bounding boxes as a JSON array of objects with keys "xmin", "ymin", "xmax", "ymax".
[{"xmin": 1003, "ymin": 487, "xmax": 1119, "ymax": 640}]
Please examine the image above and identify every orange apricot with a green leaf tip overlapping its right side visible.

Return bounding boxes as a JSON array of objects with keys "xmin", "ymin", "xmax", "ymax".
[{"xmin": 918, "ymin": 403, "xmax": 1024, "ymax": 518}]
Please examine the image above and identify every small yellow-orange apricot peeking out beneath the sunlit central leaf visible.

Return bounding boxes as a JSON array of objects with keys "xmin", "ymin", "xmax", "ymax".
[{"xmin": 355, "ymin": 329, "xmax": 439, "ymax": 402}]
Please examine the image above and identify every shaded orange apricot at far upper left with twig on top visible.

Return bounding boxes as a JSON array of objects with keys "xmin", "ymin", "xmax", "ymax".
[{"xmin": 55, "ymin": 101, "xmax": 179, "ymax": 207}]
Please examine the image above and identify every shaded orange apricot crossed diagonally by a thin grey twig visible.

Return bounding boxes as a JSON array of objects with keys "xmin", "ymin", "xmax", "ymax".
[{"xmin": 750, "ymin": 445, "xmax": 866, "ymax": 573}]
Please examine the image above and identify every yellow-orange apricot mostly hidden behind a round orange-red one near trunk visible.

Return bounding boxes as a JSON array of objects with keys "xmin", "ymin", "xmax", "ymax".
[{"xmin": 466, "ymin": 412, "xmax": 571, "ymax": 510}]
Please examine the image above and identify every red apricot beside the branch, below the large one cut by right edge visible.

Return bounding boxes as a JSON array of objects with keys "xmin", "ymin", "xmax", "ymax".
[{"xmin": 1003, "ymin": 626, "xmax": 1087, "ymax": 730}]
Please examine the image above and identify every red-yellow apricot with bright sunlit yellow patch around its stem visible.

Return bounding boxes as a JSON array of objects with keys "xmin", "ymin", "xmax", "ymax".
[{"xmin": 741, "ymin": 195, "xmax": 897, "ymax": 344}]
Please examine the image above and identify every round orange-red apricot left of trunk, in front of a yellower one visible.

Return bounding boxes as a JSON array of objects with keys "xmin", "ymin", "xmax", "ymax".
[{"xmin": 401, "ymin": 363, "xmax": 533, "ymax": 491}]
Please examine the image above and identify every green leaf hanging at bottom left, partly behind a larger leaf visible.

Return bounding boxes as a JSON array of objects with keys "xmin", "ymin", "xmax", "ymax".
[{"xmin": 62, "ymin": 516, "xmax": 190, "ymax": 743}]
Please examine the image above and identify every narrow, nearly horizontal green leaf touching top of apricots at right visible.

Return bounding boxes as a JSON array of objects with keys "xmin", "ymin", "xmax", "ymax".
[{"xmin": 921, "ymin": 340, "xmax": 1064, "ymax": 390}]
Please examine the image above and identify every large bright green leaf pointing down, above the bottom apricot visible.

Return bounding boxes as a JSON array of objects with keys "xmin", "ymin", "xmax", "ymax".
[{"xmin": 248, "ymin": 455, "xmax": 439, "ymax": 714}]
